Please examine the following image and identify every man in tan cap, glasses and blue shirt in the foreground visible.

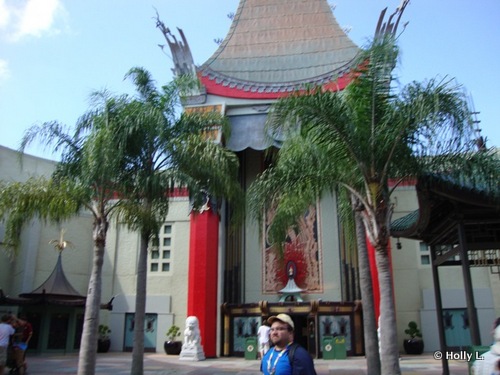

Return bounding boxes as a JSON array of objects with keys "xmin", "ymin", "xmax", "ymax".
[{"xmin": 261, "ymin": 314, "xmax": 316, "ymax": 375}]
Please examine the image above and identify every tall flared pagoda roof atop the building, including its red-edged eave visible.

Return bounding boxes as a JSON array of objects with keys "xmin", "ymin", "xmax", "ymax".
[{"xmin": 198, "ymin": 0, "xmax": 359, "ymax": 98}]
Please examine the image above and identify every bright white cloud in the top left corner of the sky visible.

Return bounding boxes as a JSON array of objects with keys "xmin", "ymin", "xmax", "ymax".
[{"xmin": 0, "ymin": 0, "xmax": 66, "ymax": 42}]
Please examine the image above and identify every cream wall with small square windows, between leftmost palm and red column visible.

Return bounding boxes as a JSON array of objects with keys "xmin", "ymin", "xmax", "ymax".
[{"xmin": 101, "ymin": 197, "xmax": 190, "ymax": 351}]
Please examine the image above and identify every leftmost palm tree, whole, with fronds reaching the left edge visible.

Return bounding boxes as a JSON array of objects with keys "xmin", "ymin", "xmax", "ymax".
[{"xmin": 0, "ymin": 91, "xmax": 135, "ymax": 375}]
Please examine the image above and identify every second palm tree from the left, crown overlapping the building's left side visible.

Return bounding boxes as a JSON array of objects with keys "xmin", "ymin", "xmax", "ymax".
[{"xmin": 117, "ymin": 68, "xmax": 241, "ymax": 375}]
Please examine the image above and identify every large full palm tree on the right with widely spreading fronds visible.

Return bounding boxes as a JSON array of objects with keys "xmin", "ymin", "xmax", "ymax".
[{"xmin": 249, "ymin": 36, "xmax": 500, "ymax": 374}]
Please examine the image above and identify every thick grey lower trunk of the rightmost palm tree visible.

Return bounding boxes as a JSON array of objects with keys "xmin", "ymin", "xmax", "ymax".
[{"xmin": 375, "ymin": 242, "xmax": 401, "ymax": 375}]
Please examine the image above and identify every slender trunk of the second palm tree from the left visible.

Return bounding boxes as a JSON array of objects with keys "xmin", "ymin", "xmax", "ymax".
[{"xmin": 130, "ymin": 232, "xmax": 150, "ymax": 375}]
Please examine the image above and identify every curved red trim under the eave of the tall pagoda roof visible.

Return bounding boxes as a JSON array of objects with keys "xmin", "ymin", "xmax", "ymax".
[{"xmin": 199, "ymin": 74, "xmax": 352, "ymax": 99}]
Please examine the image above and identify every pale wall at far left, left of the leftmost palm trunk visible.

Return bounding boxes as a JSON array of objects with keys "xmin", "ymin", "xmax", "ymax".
[{"xmin": 0, "ymin": 146, "xmax": 92, "ymax": 297}]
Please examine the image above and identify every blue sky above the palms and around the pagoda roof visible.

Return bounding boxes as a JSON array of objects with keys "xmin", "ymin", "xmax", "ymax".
[{"xmin": 0, "ymin": 0, "xmax": 500, "ymax": 157}]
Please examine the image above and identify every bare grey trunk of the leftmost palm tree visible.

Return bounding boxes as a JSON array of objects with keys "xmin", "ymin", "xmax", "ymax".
[{"xmin": 77, "ymin": 220, "xmax": 108, "ymax": 375}]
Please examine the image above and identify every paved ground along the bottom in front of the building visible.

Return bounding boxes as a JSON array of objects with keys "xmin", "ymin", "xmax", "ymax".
[{"xmin": 18, "ymin": 353, "xmax": 468, "ymax": 375}]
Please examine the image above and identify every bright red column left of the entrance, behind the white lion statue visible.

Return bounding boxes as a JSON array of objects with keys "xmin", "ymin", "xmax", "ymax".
[{"xmin": 187, "ymin": 208, "xmax": 219, "ymax": 358}]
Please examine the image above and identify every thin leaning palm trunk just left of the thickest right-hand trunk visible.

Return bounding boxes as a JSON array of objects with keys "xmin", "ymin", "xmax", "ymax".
[{"xmin": 351, "ymin": 196, "xmax": 381, "ymax": 375}]
